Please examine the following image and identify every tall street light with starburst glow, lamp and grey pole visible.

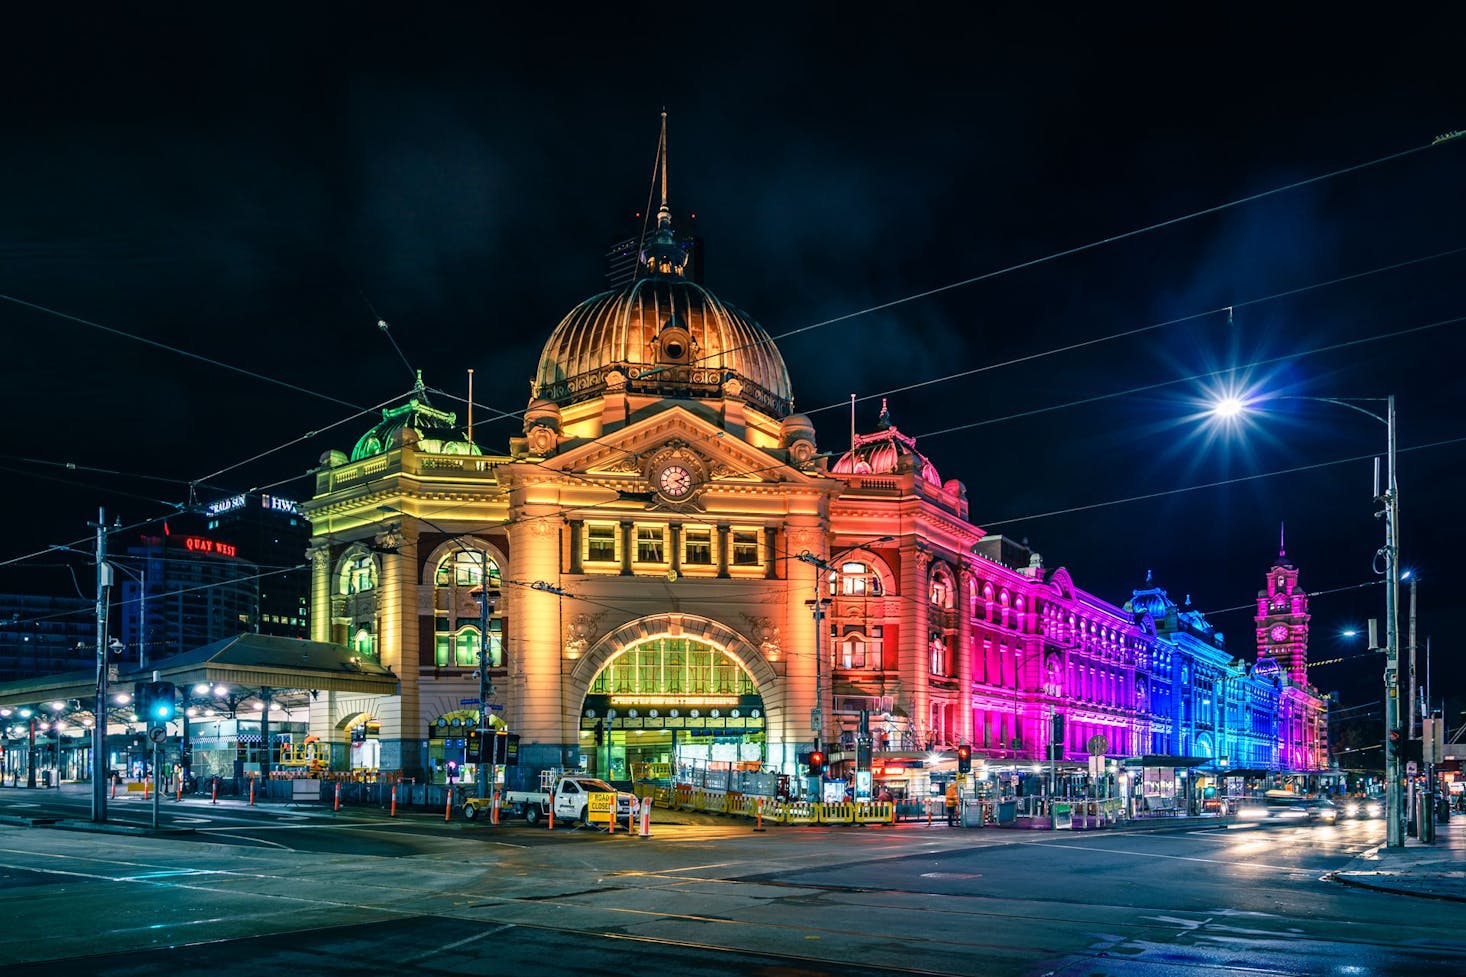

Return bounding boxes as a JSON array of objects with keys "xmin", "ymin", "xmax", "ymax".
[{"xmin": 1212, "ymin": 395, "xmax": 1404, "ymax": 848}]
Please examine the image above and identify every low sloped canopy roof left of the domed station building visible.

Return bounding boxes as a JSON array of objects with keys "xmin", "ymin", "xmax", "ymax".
[{"xmin": 0, "ymin": 634, "xmax": 400, "ymax": 706}]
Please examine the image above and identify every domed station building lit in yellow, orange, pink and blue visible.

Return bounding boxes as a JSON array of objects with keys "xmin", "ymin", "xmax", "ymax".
[{"xmin": 301, "ymin": 163, "xmax": 1327, "ymax": 786}]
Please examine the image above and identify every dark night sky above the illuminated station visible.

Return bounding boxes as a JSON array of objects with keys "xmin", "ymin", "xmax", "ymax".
[{"xmin": 0, "ymin": 4, "xmax": 1466, "ymax": 703}]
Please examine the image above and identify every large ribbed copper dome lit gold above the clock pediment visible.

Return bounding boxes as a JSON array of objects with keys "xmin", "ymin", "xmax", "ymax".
[{"xmin": 534, "ymin": 266, "xmax": 793, "ymax": 418}]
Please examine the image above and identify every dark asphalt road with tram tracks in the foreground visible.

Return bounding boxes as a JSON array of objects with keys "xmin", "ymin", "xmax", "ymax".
[{"xmin": 0, "ymin": 797, "xmax": 1466, "ymax": 977}]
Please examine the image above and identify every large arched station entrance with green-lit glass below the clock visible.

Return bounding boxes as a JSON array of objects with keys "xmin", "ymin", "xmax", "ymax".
[{"xmin": 573, "ymin": 616, "xmax": 778, "ymax": 782}]
